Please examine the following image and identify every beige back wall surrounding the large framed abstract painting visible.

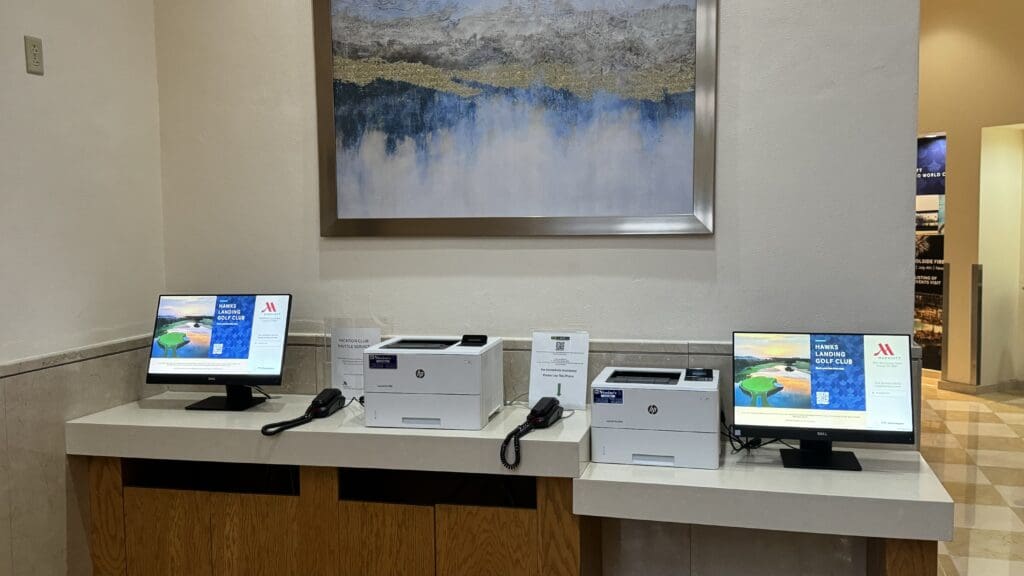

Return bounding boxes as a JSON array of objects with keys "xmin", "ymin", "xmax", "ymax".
[{"xmin": 157, "ymin": 0, "xmax": 918, "ymax": 340}]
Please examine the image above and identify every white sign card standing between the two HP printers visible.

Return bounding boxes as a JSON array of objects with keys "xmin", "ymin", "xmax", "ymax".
[{"xmin": 529, "ymin": 332, "xmax": 590, "ymax": 410}]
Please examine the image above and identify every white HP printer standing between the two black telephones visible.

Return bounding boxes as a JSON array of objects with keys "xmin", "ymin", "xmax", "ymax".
[{"xmin": 362, "ymin": 336, "xmax": 505, "ymax": 430}]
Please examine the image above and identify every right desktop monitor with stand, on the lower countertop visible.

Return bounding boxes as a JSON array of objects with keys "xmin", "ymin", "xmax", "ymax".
[{"xmin": 732, "ymin": 332, "xmax": 914, "ymax": 470}]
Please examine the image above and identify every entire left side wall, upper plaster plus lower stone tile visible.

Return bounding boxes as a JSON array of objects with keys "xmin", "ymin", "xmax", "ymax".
[{"xmin": 0, "ymin": 0, "xmax": 164, "ymax": 576}]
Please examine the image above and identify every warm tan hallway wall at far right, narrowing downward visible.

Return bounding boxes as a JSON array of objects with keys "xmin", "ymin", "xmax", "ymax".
[{"xmin": 920, "ymin": 0, "xmax": 1024, "ymax": 382}]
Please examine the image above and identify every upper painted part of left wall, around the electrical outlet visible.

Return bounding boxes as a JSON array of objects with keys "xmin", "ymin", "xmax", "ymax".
[{"xmin": 0, "ymin": 0, "xmax": 164, "ymax": 364}]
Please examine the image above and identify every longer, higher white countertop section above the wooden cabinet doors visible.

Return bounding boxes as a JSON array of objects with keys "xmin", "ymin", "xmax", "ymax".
[{"xmin": 65, "ymin": 393, "xmax": 590, "ymax": 478}]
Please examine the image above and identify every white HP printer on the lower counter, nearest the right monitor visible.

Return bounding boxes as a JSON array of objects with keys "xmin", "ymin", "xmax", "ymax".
[{"xmin": 590, "ymin": 367, "xmax": 721, "ymax": 468}]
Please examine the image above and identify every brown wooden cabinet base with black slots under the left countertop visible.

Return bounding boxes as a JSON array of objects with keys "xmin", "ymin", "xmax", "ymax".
[{"xmin": 90, "ymin": 458, "xmax": 582, "ymax": 576}]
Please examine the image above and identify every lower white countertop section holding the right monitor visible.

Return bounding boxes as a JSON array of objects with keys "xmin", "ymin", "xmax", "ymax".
[{"xmin": 572, "ymin": 448, "xmax": 953, "ymax": 537}]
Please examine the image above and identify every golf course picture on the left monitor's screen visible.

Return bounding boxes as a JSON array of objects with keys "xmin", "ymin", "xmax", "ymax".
[{"xmin": 151, "ymin": 296, "xmax": 217, "ymax": 358}]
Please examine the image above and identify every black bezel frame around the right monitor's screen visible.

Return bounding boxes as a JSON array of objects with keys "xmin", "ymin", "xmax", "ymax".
[{"xmin": 729, "ymin": 330, "xmax": 918, "ymax": 444}]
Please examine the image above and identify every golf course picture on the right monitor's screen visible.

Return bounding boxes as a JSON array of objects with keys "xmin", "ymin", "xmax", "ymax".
[{"xmin": 733, "ymin": 334, "xmax": 811, "ymax": 408}]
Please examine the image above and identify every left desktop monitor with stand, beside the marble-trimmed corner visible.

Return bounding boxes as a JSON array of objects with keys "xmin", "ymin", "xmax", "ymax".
[{"xmin": 145, "ymin": 294, "xmax": 292, "ymax": 410}]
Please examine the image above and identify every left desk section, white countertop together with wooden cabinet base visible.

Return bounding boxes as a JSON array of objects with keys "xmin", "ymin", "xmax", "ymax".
[{"xmin": 66, "ymin": 393, "xmax": 596, "ymax": 576}]
